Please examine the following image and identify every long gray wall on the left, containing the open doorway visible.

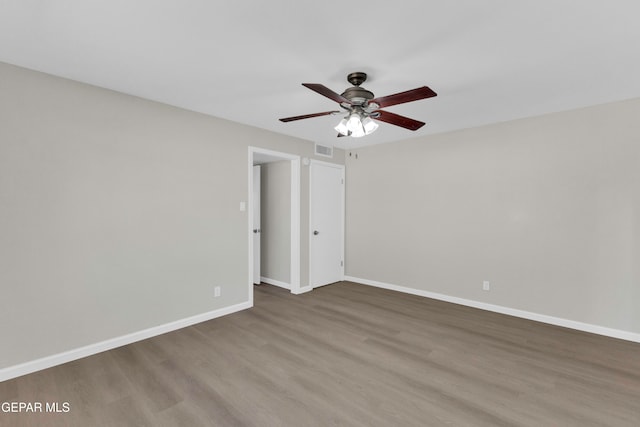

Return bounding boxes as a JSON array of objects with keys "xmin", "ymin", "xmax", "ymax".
[{"xmin": 0, "ymin": 63, "xmax": 344, "ymax": 368}]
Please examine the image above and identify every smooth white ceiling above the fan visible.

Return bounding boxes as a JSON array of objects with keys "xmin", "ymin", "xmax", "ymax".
[{"xmin": 0, "ymin": 0, "xmax": 640, "ymax": 148}]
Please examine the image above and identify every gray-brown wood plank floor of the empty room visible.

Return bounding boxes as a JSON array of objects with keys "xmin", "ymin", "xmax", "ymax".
[{"xmin": 0, "ymin": 282, "xmax": 640, "ymax": 427}]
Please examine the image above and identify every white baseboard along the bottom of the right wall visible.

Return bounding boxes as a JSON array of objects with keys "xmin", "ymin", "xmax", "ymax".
[{"xmin": 344, "ymin": 276, "xmax": 640, "ymax": 343}]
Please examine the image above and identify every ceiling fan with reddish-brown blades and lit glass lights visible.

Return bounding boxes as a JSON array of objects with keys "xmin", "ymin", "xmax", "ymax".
[{"xmin": 280, "ymin": 71, "xmax": 437, "ymax": 138}]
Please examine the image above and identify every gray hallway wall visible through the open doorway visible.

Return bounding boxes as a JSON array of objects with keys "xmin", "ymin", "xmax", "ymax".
[{"xmin": 260, "ymin": 161, "xmax": 291, "ymax": 284}]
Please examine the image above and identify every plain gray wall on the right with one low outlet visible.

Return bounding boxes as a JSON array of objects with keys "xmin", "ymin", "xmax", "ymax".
[{"xmin": 346, "ymin": 99, "xmax": 640, "ymax": 333}]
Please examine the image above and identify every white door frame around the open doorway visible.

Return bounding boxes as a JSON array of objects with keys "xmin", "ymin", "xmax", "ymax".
[{"xmin": 247, "ymin": 146, "xmax": 300, "ymax": 306}]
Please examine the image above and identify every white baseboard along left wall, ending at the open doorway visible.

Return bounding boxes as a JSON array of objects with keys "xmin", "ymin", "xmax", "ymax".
[{"xmin": 0, "ymin": 301, "xmax": 253, "ymax": 382}]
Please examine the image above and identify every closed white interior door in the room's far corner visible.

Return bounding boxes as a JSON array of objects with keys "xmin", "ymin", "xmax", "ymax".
[{"xmin": 309, "ymin": 161, "xmax": 344, "ymax": 287}]
